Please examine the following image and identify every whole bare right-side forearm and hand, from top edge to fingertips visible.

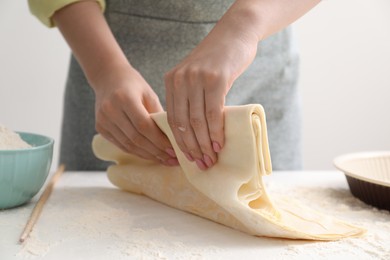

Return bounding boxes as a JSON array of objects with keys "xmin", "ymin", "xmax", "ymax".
[{"xmin": 165, "ymin": 0, "xmax": 320, "ymax": 170}]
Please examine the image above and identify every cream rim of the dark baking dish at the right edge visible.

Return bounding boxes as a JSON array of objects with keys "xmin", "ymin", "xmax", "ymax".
[{"xmin": 333, "ymin": 151, "xmax": 390, "ymax": 187}]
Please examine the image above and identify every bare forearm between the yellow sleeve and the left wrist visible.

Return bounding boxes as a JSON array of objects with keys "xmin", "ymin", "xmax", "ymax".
[{"xmin": 53, "ymin": 1, "xmax": 130, "ymax": 86}]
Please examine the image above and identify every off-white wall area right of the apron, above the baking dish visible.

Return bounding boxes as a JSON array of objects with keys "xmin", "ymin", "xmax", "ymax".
[{"xmin": 296, "ymin": 0, "xmax": 390, "ymax": 169}]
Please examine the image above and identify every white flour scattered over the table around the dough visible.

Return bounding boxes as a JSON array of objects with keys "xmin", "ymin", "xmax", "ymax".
[{"xmin": 13, "ymin": 183, "xmax": 390, "ymax": 260}]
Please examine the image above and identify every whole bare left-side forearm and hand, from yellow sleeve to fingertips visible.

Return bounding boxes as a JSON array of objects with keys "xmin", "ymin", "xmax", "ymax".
[{"xmin": 53, "ymin": 1, "xmax": 178, "ymax": 165}]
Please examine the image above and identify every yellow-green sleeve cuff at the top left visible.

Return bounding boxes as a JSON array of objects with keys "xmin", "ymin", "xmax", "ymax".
[{"xmin": 28, "ymin": 0, "xmax": 106, "ymax": 27}]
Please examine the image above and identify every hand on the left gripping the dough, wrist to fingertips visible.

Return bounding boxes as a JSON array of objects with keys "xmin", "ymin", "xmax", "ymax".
[{"xmin": 92, "ymin": 65, "xmax": 178, "ymax": 166}]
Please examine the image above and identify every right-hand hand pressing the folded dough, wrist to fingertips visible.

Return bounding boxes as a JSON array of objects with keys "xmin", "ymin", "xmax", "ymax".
[{"xmin": 165, "ymin": 13, "xmax": 258, "ymax": 170}]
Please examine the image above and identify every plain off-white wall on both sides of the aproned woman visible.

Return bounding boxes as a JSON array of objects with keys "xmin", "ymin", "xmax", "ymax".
[{"xmin": 0, "ymin": 0, "xmax": 390, "ymax": 170}]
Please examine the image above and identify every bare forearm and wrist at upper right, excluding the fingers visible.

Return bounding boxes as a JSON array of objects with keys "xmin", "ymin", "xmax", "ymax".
[{"xmin": 190, "ymin": 0, "xmax": 320, "ymax": 82}]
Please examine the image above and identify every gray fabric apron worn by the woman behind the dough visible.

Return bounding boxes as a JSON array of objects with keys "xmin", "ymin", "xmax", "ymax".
[{"xmin": 60, "ymin": 0, "xmax": 302, "ymax": 170}]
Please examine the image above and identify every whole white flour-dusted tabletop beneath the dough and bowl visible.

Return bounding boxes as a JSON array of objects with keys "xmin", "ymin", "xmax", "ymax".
[{"xmin": 0, "ymin": 171, "xmax": 390, "ymax": 260}]
